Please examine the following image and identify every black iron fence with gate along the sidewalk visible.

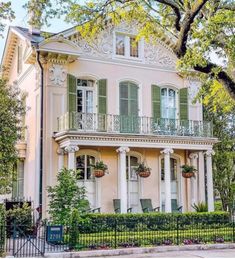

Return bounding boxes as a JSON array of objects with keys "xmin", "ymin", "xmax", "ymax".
[{"xmin": 0, "ymin": 214, "xmax": 235, "ymax": 257}]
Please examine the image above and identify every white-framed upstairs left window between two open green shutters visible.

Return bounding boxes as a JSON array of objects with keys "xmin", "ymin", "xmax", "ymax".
[{"xmin": 77, "ymin": 79, "xmax": 95, "ymax": 113}]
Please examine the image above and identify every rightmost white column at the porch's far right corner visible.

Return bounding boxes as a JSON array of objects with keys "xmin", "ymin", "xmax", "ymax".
[{"xmin": 205, "ymin": 149, "xmax": 215, "ymax": 212}]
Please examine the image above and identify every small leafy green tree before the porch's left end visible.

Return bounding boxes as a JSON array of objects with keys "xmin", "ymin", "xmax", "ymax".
[{"xmin": 47, "ymin": 168, "xmax": 89, "ymax": 225}]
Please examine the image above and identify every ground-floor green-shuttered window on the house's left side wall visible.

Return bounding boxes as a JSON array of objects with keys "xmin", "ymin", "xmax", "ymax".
[{"xmin": 12, "ymin": 160, "xmax": 24, "ymax": 198}]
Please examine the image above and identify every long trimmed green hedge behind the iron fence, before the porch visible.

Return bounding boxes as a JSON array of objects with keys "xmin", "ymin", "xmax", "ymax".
[{"xmin": 76, "ymin": 212, "xmax": 232, "ymax": 233}]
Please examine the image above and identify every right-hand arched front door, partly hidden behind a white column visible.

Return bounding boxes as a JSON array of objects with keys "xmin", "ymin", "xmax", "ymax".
[{"xmin": 161, "ymin": 158, "xmax": 179, "ymax": 211}]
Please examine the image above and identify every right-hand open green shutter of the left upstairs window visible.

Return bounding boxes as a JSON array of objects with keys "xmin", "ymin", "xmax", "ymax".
[{"xmin": 98, "ymin": 79, "xmax": 107, "ymax": 114}]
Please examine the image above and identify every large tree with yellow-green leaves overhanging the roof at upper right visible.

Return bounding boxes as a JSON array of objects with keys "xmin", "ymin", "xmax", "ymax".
[{"xmin": 26, "ymin": 0, "xmax": 235, "ymax": 99}]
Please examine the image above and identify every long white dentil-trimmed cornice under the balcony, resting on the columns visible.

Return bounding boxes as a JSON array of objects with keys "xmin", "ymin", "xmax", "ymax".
[{"xmin": 54, "ymin": 131, "xmax": 218, "ymax": 150}]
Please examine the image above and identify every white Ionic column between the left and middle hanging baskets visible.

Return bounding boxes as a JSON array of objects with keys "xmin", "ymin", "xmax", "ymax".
[{"xmin": 116, "ymin": 147, "xmax": 130, "ymax": 213}]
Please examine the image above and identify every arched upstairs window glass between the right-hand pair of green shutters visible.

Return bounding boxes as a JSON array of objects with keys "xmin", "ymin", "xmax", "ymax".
[{"xmin": 161, "ymin": 88, "xmax": 176, "ymax": 119}]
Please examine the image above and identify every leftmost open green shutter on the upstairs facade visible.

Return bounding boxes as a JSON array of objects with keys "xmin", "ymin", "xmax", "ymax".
[{"xmin": 67, "ymin": 74, "xmax": 77, "ymax": 113}]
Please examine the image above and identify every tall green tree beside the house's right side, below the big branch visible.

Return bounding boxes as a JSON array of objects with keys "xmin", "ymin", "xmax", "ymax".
[{"xmin": 201, "ymin": 82, "xmax": 235, "ymax": 211}]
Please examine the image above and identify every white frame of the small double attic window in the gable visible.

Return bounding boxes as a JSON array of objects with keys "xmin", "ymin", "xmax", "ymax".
[{"xmin": 113, "ymin": 31, "xmax": 144, "ymax": 62}]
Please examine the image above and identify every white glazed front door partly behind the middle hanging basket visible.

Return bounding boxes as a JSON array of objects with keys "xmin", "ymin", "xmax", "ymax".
[{"xmin": 126, "ymin": 155, "xmax": 139, "ymax": 212}]
